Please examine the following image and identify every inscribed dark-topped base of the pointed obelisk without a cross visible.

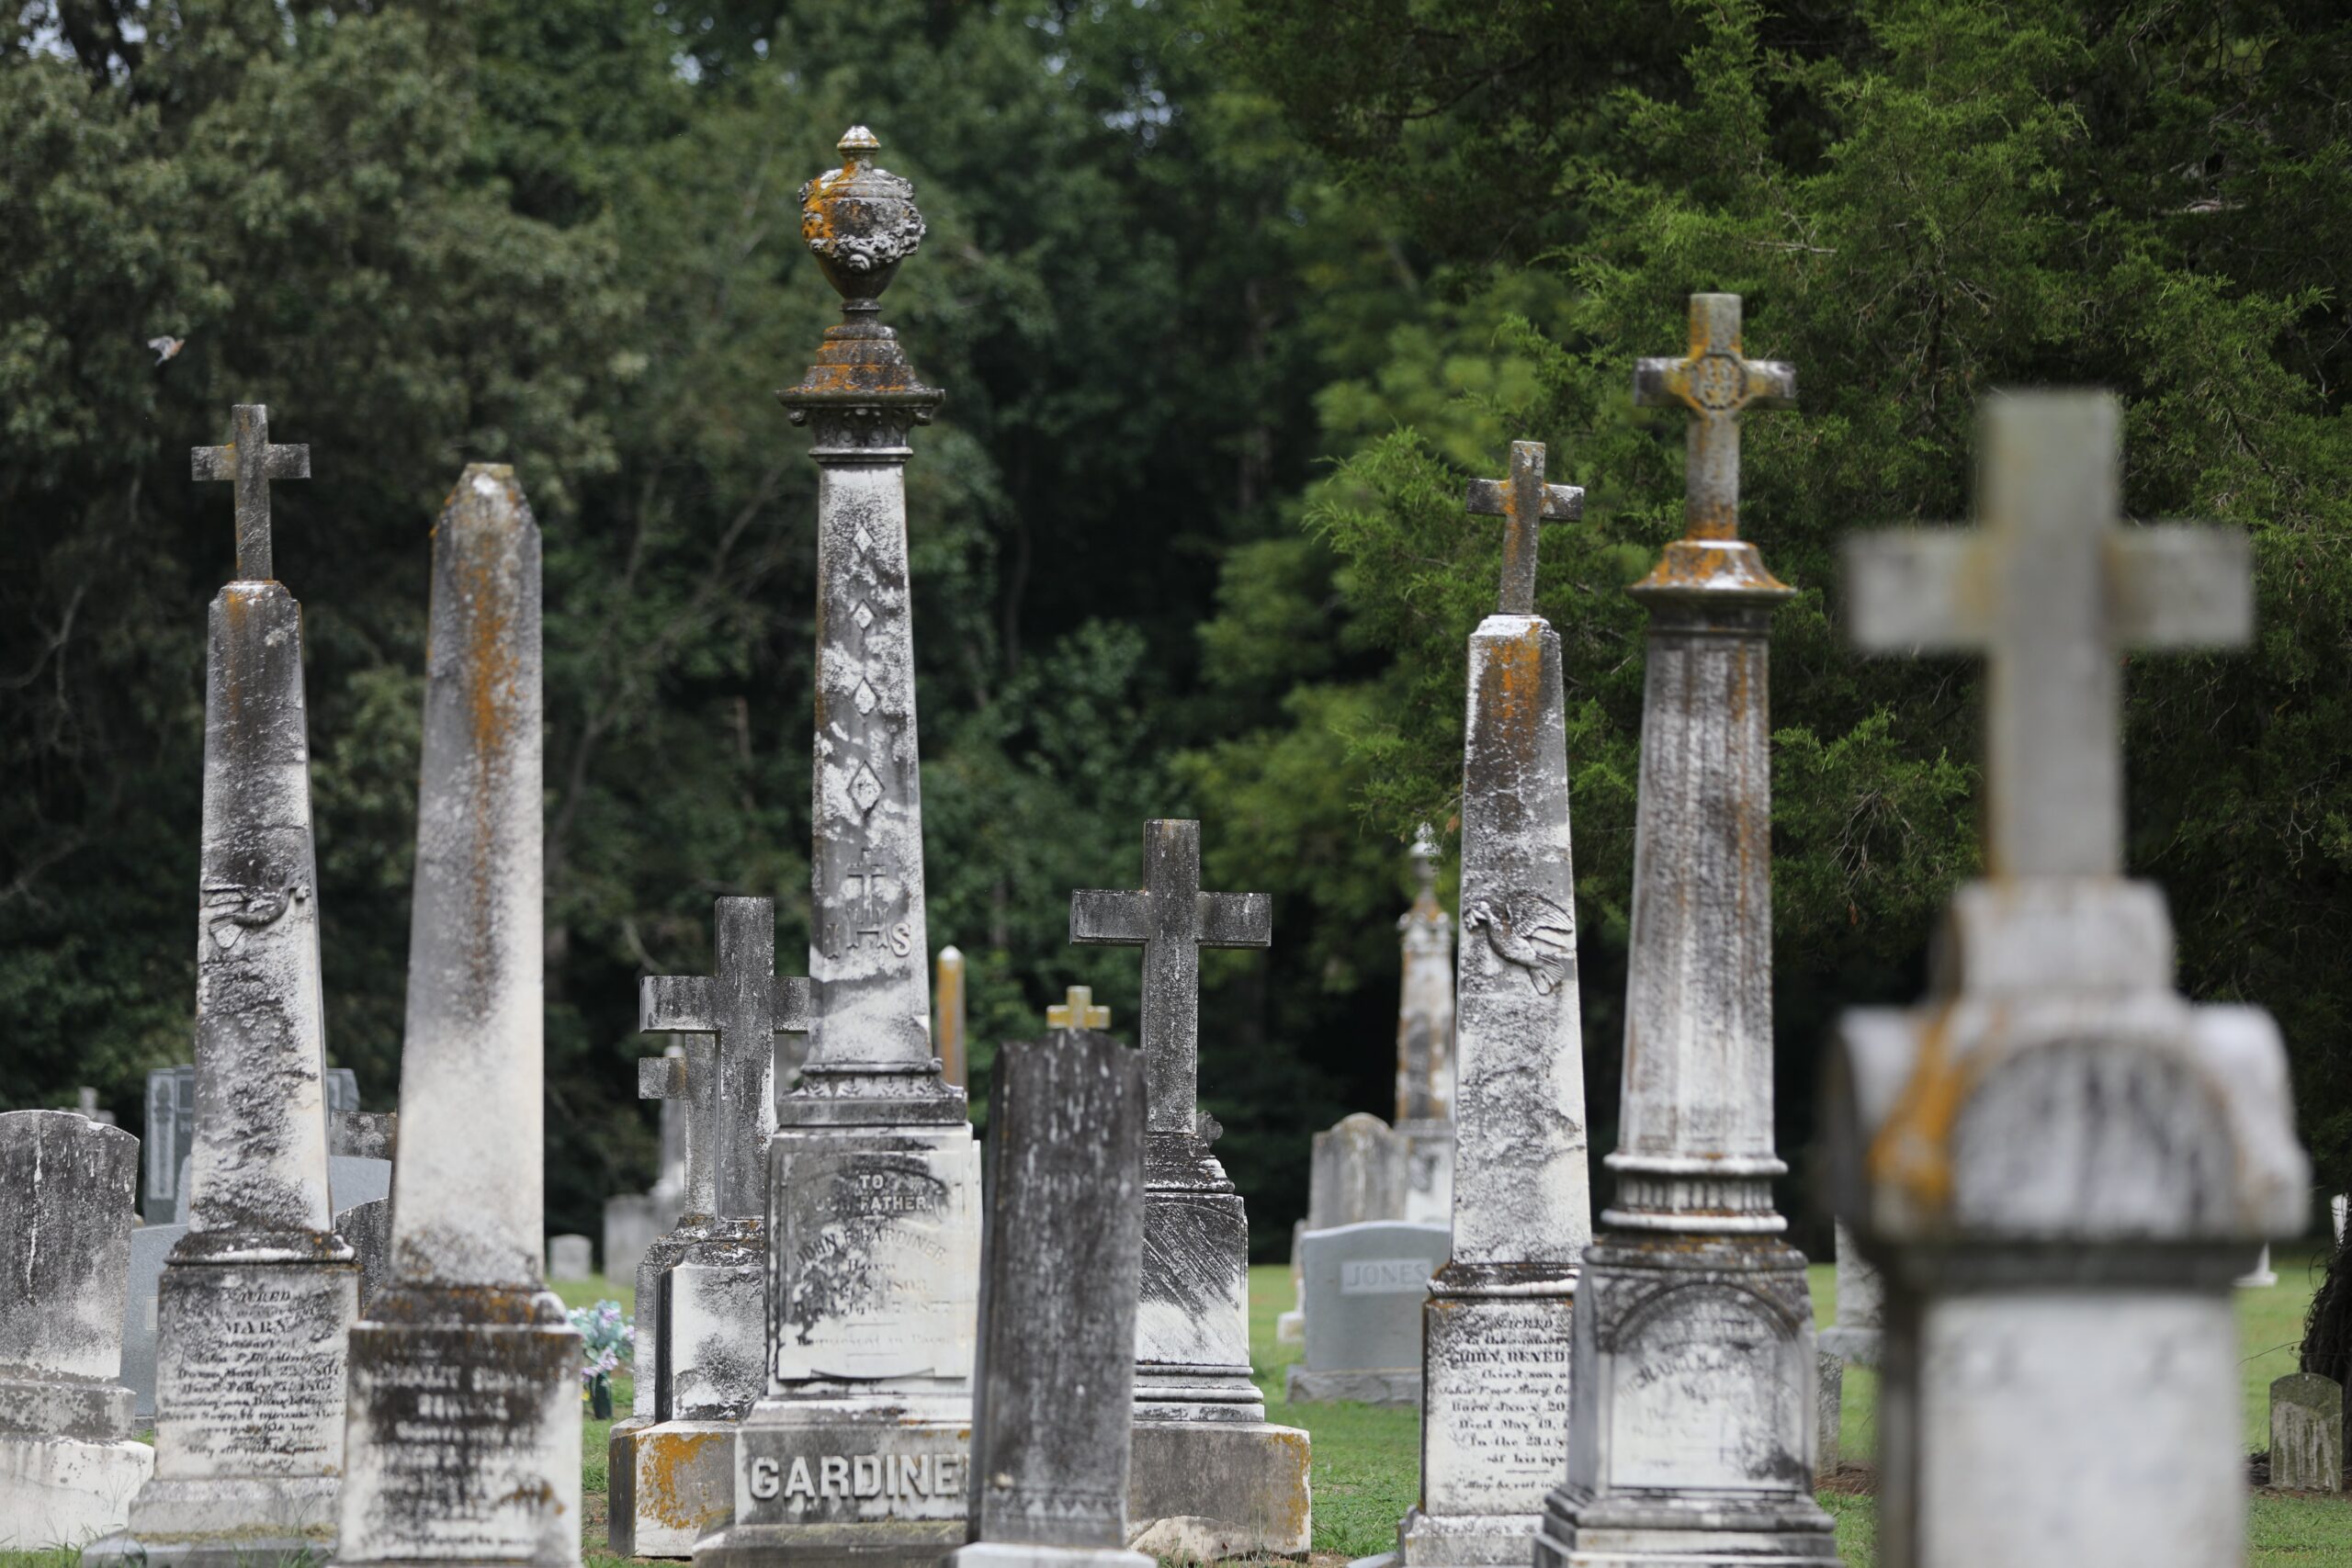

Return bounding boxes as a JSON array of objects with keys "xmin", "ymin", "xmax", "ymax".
[{"xmin": 334, "ymin": 1283, "xmax": 581, "ymax": 1568}]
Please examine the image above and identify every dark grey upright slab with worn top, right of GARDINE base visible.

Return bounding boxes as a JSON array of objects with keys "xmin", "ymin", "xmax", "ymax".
[{"xmin": 941, "ymin": 1027, "xmax": 1155, "ymax": 1568}]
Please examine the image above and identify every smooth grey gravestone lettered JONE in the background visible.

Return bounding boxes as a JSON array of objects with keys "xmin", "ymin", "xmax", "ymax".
[{"xmin": 1284, "ymin": 1220, "xmax": 1453, "ymax": 1405}]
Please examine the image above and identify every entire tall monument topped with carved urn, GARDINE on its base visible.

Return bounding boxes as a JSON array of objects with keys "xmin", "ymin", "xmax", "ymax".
[{"xmin": 694, "ymin": 127, "xmax": 981, "ymax": 1568}]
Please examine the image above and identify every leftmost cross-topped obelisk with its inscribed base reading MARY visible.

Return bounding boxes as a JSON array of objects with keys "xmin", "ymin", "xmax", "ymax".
[{"xmin": 87, "ymin": 404, "xmax": 360, "ymax": 1565}]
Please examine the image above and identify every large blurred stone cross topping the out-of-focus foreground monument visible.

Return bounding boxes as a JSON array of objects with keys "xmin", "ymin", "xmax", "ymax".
[{"xmin": 1847, "ymin": 392, "xmax": 2253, "ymax": 877}]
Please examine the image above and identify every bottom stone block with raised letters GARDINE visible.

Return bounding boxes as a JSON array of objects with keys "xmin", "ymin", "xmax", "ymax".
[{"xmin": 686, "ymin": 1392, "xmax": 971, "ymax": 1568}]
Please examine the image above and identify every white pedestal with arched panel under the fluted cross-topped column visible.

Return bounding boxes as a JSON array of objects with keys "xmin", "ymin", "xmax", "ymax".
[{"xmin": 1521, "ymin": 1232, "xmax": 1839, "ymax": 1568}]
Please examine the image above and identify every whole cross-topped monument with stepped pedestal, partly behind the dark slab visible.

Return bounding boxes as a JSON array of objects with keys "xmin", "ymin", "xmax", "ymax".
[{"xmin": 1070, "ymin": 820, "xmax": 1310, "ymax": 1561}]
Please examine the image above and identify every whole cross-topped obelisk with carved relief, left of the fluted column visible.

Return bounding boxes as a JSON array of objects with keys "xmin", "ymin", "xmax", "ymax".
[{"xmin": 1397, "ymin": 442, "xmax": 1592, "ymax": 1568}]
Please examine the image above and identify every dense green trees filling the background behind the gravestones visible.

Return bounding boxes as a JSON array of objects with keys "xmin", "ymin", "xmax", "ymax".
[{"xmin": 0, "ymin": 0, "xmax": 2352, "ymax": 1288}]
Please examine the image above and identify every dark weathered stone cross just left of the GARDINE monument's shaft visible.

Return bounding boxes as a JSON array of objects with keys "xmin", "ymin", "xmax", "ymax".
[{"xmin": 638, "ymin": 898, "xmax": 809, "ymax": 1215}]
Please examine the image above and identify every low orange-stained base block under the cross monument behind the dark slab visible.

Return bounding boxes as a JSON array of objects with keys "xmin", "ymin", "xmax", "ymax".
[{"xmin": 1126, "ymin": 1416, "xmax": 1312, "ymax": 1563}]
